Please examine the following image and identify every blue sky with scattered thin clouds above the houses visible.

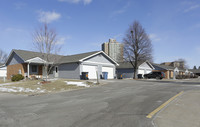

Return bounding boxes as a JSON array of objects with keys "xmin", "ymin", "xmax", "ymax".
[{"xmin": 0, "ymin": 0, "xmax": 200, "ymax": 67}]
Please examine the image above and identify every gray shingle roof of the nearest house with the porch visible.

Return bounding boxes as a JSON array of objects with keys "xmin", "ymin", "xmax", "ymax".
[{"xmin": 13, "ymin": 49, "xmax": 99, "ymax": 64}]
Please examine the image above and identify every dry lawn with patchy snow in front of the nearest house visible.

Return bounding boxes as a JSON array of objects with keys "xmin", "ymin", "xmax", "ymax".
[{"xmin": 0, "ymin": 79, "xmax": 93, "ymax": 94}]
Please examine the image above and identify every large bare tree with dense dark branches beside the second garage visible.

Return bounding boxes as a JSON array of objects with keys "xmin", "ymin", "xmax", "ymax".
[{"xmin": 123, "ymin": 21, "xmax": 152, "ymax": 79}]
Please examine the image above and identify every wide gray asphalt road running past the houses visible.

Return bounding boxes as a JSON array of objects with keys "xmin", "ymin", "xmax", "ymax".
[{"xmin": 0, "ymin": 80, "xmax": 200, "ymax": 127}]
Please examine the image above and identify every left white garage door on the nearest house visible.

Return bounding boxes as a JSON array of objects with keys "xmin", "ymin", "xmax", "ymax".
[{"xmin": 83, "ymin": 65, "xmax": 97, "ymax": 79}]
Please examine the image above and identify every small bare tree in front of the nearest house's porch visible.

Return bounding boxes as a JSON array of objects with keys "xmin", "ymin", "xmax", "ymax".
[{"xmin": 33, "ymin": 23, "xmax": 61, "ymax": 80}]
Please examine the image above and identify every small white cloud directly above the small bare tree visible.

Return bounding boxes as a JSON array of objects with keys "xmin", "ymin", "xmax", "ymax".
[{"xmin": 38, "ymin": 11, "xmax": 61, "ymax": 23}]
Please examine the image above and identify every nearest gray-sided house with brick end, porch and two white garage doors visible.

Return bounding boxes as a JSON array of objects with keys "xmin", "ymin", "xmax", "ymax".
[{"xmin": 6, "ymin": 50, "xmax": 118, "ymax": 79}]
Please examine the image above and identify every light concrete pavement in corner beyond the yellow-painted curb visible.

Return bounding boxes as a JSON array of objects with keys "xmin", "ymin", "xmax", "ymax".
[{"xmin": 153, "ymin": 91, "xmax": 200, "ymax": 127}]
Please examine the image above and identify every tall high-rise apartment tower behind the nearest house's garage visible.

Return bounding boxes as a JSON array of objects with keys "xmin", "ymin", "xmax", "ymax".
[{"xmin": 102, "ymin": 39, "xmax": 124, "ymax": 62}]
